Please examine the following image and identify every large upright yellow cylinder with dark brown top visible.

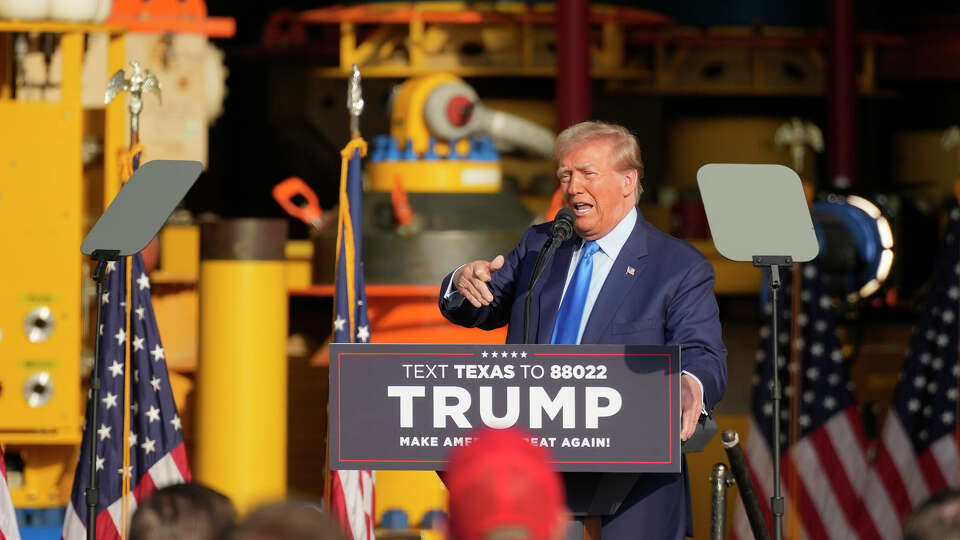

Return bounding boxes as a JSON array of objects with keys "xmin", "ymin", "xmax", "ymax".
[{"xmin": 196, "ymin": 219, "xmax": 287, "ymax": 513}]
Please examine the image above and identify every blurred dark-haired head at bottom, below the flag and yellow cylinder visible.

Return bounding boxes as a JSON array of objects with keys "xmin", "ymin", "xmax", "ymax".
[{"xmin": 130, "ymin": 484, "xmax": 237, "ymax": 540}]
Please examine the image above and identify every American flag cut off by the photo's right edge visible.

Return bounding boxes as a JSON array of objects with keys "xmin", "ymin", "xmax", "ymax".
[{"xmin": 863, "ymin": 208, "xmax": 960, "ymax": 538}]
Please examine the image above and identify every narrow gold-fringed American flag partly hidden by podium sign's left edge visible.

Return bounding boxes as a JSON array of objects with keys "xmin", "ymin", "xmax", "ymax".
[{"xmin": 330, "ymin": 138, "xmax": 375, "ymax": 540}]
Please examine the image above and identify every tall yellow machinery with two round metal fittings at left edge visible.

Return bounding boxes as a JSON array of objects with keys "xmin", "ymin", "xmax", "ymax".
[{"xmin": 0, "ymin": 21, "xmax": 125, "ymax": 508}]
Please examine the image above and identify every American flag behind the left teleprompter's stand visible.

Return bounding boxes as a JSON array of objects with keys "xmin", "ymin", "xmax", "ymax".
[{"xmin": 63, "ymin": 254, "xmax": 190, "ymax": 540}]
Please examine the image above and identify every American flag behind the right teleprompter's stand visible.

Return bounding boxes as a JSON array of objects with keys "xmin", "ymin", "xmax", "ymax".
[{"xmin": 733, "ymin": 260, "xmax": 877, "ymax": 539}]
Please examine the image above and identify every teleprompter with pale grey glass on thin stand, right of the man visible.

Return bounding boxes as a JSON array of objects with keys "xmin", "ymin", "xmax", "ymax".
[{"xmin": 697, "ymin": 163, "xmax": 820, "ymax": 540}]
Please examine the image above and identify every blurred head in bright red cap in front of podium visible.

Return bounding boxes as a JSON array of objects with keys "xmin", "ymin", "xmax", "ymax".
[{"xmin": 444, "ymin": 429, "xmax": 570, "ymax": 540}]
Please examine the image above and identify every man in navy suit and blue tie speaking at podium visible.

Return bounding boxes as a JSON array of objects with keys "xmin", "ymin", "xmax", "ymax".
[{"xmin": 440, "ymin": 122, "xmax": 727, "ymax": 540}]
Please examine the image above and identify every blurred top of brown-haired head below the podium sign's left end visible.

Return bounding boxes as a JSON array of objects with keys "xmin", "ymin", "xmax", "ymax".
[{"xmin": 231, "ymin": 502, "xmax": 344, "ymax": 540}]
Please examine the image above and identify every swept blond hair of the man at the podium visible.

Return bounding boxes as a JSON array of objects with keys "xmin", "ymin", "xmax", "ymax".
[{"xmin": 553, "ymin": 120, "xmax": 643, "ymax": 201}]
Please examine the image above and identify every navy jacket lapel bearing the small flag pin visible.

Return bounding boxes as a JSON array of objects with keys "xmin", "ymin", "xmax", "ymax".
[{"xmin": 580, "ymin": 214, "xmax": 647, "ymax": 343}]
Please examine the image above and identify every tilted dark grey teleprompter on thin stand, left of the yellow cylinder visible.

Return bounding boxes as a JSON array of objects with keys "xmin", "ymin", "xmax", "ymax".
[{"xmin": 80, "ymin": 160, "xmax": 202, "ymax": 540}]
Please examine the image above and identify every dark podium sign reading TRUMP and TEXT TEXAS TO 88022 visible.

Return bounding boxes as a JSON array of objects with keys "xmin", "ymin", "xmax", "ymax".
[{"xmin": 329, "ymin": 343, "xmax": 680, "ymax": 472}]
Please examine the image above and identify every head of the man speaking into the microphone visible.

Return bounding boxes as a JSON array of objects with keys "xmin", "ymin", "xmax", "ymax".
[{"xmin": 554, "ymin": 121, "xmax": 643, "ymax": 240}]
